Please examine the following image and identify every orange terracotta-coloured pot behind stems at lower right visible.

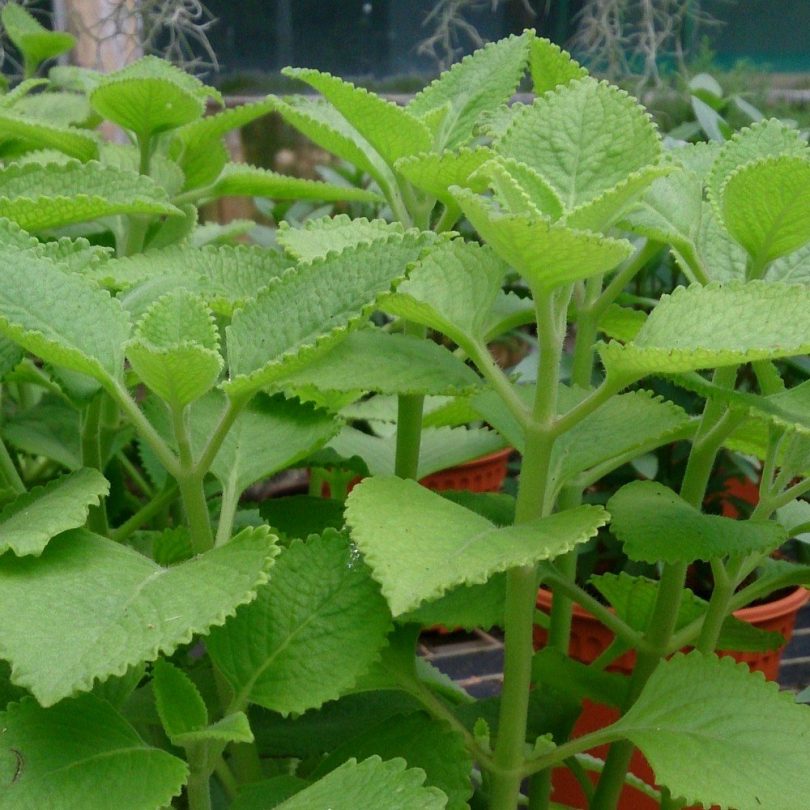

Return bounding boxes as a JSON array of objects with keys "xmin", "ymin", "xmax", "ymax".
[{"xmin": 534, "ymin": 588, "xmax": 810, "ymax": 810}]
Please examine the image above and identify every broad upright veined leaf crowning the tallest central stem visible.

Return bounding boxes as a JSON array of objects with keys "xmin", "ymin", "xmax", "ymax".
[{"xmin": 493, "ymin": 77, "xmax": 661, "ymax": 209}]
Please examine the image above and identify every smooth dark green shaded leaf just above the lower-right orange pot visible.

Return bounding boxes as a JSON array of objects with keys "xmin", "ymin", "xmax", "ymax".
[{"xmin": 608, "ymin": 481, "xmax": 787, "ymax": 563}]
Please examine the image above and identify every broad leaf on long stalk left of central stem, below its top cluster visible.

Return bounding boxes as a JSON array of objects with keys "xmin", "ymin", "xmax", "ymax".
[{"xmin": 380, "ymin": 239, "xmax": 509, "ymax": 352}]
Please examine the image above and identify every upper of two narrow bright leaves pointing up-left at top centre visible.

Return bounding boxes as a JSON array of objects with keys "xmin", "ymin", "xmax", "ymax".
[{"xmin": 282, "ymin": 68, "xmax": 432, "ymax": 165}]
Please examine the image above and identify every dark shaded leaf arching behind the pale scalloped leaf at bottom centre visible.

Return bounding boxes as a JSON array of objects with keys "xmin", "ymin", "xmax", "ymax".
[{"xmin": 312, "ymin": 712, "xmax": 472, "ymax": 810}]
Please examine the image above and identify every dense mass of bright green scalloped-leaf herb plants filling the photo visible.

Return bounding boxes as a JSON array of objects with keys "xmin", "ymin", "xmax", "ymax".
[{"xmin": 0, "ymin": 15, "xmax": 810, "ymax": 810}]
